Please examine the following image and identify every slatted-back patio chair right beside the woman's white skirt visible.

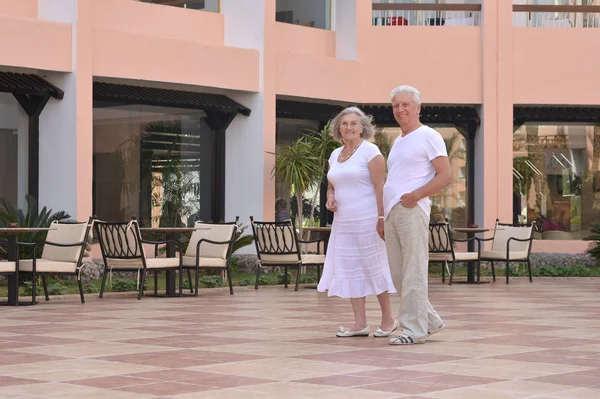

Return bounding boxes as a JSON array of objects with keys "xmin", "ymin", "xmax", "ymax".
[{"xmin": 250, "ymin": 216, "xmax": 325, "ymax": 291}]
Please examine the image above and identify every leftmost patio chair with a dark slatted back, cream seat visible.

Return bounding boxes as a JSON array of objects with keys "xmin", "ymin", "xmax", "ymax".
[{"xmin": 94, "ymin": 217, "xmax": 183, "ymax": 300}]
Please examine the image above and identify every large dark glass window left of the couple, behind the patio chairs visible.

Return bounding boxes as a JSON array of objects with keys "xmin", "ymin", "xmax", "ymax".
[{"xmin": 93, "ymin": 105, "xmax": 215, "ymax": 227}]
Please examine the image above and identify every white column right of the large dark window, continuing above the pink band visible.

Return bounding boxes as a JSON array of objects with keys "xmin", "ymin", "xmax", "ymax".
[{"xmin": 221, "ymin": 0, "xmax": 268, "ymax": 225}]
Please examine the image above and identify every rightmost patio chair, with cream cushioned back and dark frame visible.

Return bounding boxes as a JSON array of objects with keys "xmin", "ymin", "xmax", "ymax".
[{"xmin": 477, "ymin": 219, "xmax": 535, "ymax": 284}]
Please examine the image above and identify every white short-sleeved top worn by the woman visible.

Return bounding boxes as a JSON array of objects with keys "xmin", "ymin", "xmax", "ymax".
[{"xmin": 327, "ymin": 141, "xmax": 381, "ymax": 221}]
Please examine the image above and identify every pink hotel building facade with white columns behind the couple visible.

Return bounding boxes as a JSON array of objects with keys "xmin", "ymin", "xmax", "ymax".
[{"xmin": 0, "ymin": 0, "xmax": 600, "ymax": 253}]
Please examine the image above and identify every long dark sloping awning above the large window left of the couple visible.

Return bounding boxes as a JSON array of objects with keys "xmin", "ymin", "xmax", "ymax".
[{"xmin": 94, "ymin": 82, "xmax": 250, "ymax": 116}]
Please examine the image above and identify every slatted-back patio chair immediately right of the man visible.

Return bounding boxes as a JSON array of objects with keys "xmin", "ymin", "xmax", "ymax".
[{"xmin": 429, "ymin": 221, "xmax": 481, "ymax": 285}]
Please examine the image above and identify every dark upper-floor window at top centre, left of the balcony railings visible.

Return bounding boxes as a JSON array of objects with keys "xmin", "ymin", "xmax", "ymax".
[{"xmin": 275, "ymin": 0, "xmax": 331, "ymax": 29}]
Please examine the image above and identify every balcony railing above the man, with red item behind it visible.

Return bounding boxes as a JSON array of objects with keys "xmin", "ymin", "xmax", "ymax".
[{"xmin": 372, "ymin": 3, "xmax": 481, "ymax": 26}]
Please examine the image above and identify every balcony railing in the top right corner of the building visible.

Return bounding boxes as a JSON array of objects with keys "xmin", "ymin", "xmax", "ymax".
[{"xmin": 513, "ymin": 4, "xmax": 600, "ymax": 28}]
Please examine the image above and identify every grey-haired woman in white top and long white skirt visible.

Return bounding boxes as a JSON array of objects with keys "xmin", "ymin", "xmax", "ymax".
[{"xmin": 318, "ymin": 107, "xmax": 398, "ymax": 337}]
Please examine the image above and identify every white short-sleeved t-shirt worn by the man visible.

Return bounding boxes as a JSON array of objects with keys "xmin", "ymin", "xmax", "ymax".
[{"xmin": 383, "ymin": 125, "xmax": 448, "ymax": 219}]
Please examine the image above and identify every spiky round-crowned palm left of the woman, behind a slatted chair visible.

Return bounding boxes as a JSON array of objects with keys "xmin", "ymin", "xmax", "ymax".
[{"xmin": 272, "ymin": 136, "xmax": 323, "ymax": 233}]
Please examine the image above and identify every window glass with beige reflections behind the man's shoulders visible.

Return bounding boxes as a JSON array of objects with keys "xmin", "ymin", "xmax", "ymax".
[{"xmin": 374, "ymin": 127, "xmax": 469, "ymax": 227}]
